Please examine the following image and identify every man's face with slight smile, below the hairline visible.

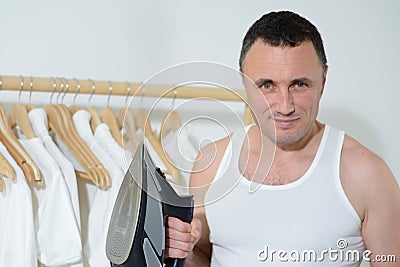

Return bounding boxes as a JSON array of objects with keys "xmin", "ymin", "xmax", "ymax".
[{"xmin": 242, "ymin": 40, "xmax": 327, "ymax": 146}]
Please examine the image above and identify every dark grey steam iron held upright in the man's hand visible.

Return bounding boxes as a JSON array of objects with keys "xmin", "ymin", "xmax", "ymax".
[{"xmin": 106, "ymin": 144, "xmax": 193, "ymax": 267}]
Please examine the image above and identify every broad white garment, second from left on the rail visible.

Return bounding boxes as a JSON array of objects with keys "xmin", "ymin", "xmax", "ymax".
[{"xmin": 20, "ymin": 136, "xmax": 82, "ymax": 266}]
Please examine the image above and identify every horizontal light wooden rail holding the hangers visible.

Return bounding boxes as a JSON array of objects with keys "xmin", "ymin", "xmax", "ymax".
[{"xmin": 0, "ymin": 76, "xmax": 245, "ymax": 101}]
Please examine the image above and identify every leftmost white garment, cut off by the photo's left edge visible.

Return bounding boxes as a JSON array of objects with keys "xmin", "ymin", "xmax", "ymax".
[{"xmin": 0, "ymin": 142, "xmax": 37, "ymax": 267}]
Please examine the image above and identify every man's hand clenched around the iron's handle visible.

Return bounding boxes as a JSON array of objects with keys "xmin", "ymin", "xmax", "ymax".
[{"xmin": 165, "ymin": 217, "xmax": 202, "ymax": 258}]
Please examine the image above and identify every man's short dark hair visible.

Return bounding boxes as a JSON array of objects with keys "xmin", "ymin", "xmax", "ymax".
[{"xmin": 239, "ymin": 11, "xmax": 327, "ymax": 71}]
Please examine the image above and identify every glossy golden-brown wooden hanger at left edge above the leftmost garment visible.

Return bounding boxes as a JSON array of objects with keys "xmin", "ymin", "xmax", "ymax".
[{"xmin": 0, "ymin": 104, "xmax": 42, "ymax": 183}]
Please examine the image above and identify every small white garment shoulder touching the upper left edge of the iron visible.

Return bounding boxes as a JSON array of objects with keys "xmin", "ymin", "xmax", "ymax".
[{"xmin": 94, "ymin": 123, "xmax": 132, "ymax": 173}]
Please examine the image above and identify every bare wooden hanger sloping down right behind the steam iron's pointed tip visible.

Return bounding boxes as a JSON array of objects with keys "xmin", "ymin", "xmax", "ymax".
[{"xmin": 133, "ymin": 108, "xmax": 178, "ymax": 179}]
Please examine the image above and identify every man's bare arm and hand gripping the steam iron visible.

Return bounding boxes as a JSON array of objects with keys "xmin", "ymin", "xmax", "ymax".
[{"xmin": 166, "ymin": 137, "xmax": 229, "ymax": 267}]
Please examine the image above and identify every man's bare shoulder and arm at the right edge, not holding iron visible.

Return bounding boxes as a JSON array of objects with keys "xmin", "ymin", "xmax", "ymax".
[{"xmin": 340, "ymin": 136, "xmax": 400, "ymax": 267}]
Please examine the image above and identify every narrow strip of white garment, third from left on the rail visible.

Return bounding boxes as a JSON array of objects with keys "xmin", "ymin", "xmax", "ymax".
[{"xmin": 28, "ymin": 108, "xmax": 82, "ymax": 267}]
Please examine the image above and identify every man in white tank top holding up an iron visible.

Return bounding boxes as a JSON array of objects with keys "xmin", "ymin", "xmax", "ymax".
[{"xmin": 166, "ymin": 11, "xmax": 400, "ymax": 267}]
